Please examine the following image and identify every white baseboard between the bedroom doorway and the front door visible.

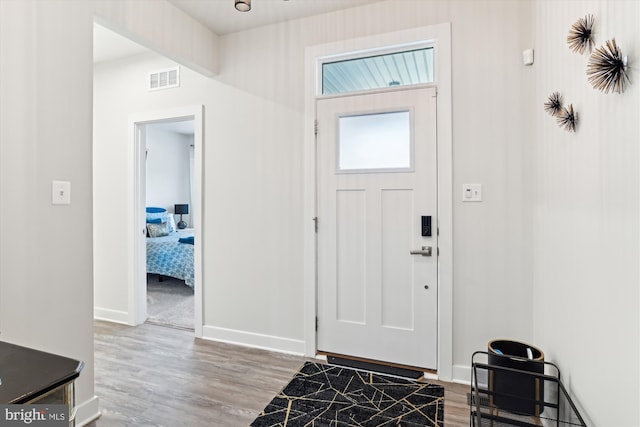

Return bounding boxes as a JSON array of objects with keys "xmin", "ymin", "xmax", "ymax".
[{"xmin": 202, "ymin": 326, "xmax": 305, "ymax": 356}]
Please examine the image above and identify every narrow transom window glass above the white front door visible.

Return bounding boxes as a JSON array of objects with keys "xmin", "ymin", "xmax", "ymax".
[{"xmin": 321, "ymin": 46, "xmax": 434, "ymax": 95}]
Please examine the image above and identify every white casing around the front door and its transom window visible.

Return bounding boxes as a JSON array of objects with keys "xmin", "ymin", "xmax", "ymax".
[{"xmin": 303, "ymin": 23, "xmax": 453, "ymax": 381}]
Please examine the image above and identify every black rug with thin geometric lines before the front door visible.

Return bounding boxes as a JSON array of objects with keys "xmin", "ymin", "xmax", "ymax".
[{"xmin": 251, "ymin": 362, "xmax": 444, "ymax": 427}]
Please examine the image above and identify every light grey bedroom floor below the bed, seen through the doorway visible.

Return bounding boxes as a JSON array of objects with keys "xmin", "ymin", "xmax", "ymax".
[{"xmin": 147, "ymin": 274, "xmax": 194, "ymax": 330}]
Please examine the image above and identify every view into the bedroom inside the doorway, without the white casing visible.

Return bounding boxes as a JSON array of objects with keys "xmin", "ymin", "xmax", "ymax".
[{"xmin": 144, "ymin": 120, "xmax": 195, "ymax": 330}]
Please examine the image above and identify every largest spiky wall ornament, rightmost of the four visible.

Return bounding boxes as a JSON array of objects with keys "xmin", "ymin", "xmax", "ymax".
[{"xmin": 587, "ymin": 39, "xmax": 629, "ymax": 93}]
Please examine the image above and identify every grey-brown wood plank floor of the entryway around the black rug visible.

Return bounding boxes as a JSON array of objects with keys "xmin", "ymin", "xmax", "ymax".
[{"xmin": 88, "ymin": 321, "xmax": 469, "ymax": 427}]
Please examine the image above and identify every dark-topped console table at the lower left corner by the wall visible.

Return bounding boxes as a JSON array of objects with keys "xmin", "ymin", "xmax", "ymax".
[{"xmin": 0, "ymin": 342, "xmax": 84, "ymax": 425}]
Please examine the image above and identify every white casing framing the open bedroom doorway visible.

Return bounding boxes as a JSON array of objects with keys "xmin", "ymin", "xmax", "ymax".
[{"xmin": 128, "ymin": 105, "xmax": 204, "ymax": 338}]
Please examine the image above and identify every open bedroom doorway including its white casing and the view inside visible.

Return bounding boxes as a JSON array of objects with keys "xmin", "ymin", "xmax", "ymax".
[{"xmin": 129, "ymin": 105, "xmax": 203, "ymax": 337}]
